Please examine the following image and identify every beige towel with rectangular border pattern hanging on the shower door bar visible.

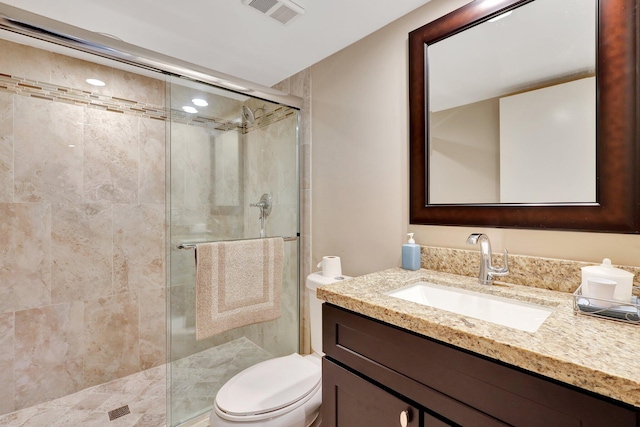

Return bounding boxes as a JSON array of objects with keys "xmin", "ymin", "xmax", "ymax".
[{"xmin": 196, "ymin": 237, "xmax": 284, "ymax": 340}]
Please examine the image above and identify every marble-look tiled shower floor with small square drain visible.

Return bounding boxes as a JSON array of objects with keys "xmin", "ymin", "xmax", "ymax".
[{"xmin": 0, "ymin": 338, "xmax": 273, "ymax": 427}]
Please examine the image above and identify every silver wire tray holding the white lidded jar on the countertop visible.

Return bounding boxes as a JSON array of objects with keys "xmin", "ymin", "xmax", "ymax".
[{"xmin": 573, "ymin": 285, "xmax": 640, "ymax": 325}]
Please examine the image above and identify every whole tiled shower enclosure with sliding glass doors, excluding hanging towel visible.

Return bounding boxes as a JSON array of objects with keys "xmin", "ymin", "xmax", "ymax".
[{"xmin": 0, "ymin": 3, "xmax": 300, "ymax": 426}]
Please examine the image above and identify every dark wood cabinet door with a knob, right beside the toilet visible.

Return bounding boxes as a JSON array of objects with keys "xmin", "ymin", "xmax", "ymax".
[{"xmin": 322, "ymin": 359, "xmax": 422, "ymax": 427}]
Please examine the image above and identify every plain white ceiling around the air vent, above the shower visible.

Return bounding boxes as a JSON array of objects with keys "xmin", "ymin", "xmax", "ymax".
[{"xmin": 3, "ymin": 0, "xmax": 429, "ymax": 86}]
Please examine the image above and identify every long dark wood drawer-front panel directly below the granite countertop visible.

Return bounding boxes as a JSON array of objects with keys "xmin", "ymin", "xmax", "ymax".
[{"xmin": 322, "ymin": 304, "xmax": 640, "ymax": 427}]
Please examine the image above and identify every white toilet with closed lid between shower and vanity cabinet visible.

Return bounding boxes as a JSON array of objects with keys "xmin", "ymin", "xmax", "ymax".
[{"xmin": 209, "ymin": 272, "xmax": 347, "ymax": 427}]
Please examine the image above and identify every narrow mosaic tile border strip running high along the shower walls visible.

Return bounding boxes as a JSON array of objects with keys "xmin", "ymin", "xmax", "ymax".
[{"xmin": 0, "ymin": 73, "xmax": 295, "ymax": 134}]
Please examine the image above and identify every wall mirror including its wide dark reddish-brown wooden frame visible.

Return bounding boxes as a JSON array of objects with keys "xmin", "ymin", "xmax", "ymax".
[{"xmin": 409, "ymin": 0, "xmax": 639, "ymax": 232}]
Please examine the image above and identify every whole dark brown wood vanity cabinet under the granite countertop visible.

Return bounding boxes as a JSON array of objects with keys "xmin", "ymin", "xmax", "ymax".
[{"xmin": 322, "ymin": 303, "xmax": 637, "ymax": 427}]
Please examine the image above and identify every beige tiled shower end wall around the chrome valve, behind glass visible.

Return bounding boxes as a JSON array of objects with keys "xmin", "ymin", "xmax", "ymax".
[{"xmin": 244, "ymin": 100, "xmax": 300, "ymax": 356}]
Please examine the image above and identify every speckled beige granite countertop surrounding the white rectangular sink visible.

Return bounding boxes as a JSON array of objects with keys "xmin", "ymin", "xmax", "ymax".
[{"xmin": 317, "ymin": 268, "xmax": 640, "ymax": 407}]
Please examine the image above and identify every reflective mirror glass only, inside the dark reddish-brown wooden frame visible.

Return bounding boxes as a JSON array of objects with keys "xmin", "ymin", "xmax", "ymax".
[{"xmin": 427, "ymin": 0, "xmax": 596, "ymax": 204}]
